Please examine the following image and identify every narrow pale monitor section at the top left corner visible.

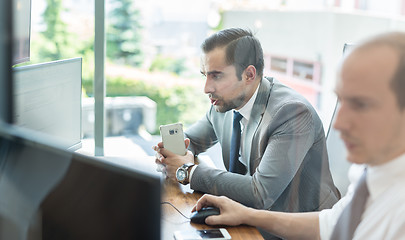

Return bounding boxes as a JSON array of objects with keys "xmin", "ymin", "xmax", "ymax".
[{"xmin": 11, "ymin": 0, "xmax": 31, "ymax": 64}]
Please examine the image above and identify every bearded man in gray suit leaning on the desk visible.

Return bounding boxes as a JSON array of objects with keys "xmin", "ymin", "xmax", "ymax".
[{"xmin": 154, "ymin": 28, "xmax": 340, "ymax": 216}]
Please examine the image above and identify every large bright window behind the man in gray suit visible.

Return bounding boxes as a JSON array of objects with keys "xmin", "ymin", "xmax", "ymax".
[{"xmin": 31, "ymin": 0, "xmax": 405, "ymax": 161}]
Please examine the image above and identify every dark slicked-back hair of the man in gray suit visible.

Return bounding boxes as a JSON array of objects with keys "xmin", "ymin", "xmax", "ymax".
[{"xmin": 201, "ymin": 28, "xmax": 264, "ymax": 80}]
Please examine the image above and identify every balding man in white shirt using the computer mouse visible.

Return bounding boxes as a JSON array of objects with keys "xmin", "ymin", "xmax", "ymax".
[{"xmin": 193, "ymin": 32, "xmax": 405, "ymax": 240}]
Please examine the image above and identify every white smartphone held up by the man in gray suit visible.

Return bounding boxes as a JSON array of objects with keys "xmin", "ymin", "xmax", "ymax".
[{"xmin": 160, "ymin": 123, "xmax": 187, "ymax": 156}]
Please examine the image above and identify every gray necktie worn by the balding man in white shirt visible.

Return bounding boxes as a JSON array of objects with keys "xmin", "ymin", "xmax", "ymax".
[{"xmin": 330, "ymin": 169, "xmax": 369, "ymax": 240}]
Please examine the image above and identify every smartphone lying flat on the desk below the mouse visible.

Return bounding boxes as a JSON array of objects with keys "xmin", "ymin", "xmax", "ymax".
[{"xmin": 174, "ymin": 228, "xmax": 231, "ymax": 240}]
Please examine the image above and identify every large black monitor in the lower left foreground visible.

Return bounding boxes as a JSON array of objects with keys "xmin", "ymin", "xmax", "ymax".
[{"xmin": 0, "ymin": 124, "xmax": 161, "ymax": 240}]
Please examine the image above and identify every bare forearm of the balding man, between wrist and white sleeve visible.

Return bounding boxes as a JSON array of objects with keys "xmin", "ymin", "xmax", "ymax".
[{"xmin": 242, "ymin": 209, "xmax": 320, "ymax": 240}]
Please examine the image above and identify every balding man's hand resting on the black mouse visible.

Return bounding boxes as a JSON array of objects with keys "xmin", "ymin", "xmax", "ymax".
[{"xmin": 191, "ymin": 194, "xmax": 250, "ymax": 226}]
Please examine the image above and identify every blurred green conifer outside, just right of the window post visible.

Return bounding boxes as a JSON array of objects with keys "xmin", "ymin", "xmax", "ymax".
[{"xmin": 107, "ymin": 0, "xmax": 143, "ymax": 66}]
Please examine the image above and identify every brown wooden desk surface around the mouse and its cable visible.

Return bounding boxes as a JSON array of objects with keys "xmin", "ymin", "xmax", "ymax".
[{"xmin": 162, "ymin": 179, "xmax": 263, "ymax": 240}]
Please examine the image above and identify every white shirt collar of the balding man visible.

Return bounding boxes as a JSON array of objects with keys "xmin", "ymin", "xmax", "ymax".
[{"xmin": 367, "ymin": 154, "xmax": 405, "ymax": 202}]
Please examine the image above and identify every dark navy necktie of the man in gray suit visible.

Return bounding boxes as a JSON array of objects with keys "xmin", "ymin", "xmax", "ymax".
[{"xmin": 229, "ymin": 111, "xmax": 246, "ymax": 174}]
